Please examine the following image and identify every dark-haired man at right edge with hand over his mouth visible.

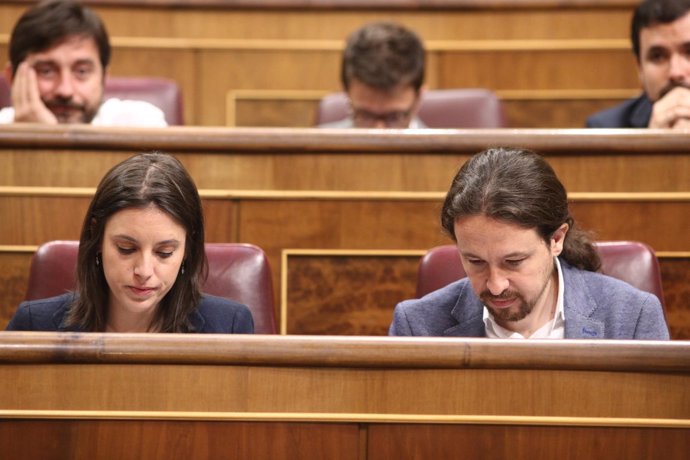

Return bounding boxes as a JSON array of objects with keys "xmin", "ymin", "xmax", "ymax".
[{"xmin": 587, "ymin": 0, "xmax": 690, "ymax": 130}]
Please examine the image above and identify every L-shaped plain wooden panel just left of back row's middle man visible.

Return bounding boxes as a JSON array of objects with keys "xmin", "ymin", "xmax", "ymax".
[{"xmin": 197, "ymin": 50, "xmax": 339, "ymax": 126}]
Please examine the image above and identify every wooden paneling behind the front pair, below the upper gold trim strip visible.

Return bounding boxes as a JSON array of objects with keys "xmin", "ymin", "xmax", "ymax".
[{"xmin": 0, "ymin": 188, "xmax": 690, "ymax": 338}]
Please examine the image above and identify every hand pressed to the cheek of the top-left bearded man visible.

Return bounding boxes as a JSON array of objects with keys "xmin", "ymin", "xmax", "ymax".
[{"xmin": 12, "ymin": 61, "xmax": 58, "ymax": 124}]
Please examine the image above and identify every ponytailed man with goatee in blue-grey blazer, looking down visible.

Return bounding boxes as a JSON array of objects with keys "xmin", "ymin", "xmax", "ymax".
[{"xmin": 389, "ymin": 148, "xmax": 669, "ymax": 340}]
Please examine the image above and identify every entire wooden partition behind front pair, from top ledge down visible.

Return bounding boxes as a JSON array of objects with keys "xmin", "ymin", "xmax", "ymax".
[{"xmin": 0, "ymin": 126, "xmax": 690, "ymax": 338}]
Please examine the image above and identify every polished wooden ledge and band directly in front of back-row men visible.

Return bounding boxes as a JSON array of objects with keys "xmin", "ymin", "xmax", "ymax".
[{"xmin": 0, "ymin": 125, "xmax": 690, "ymax": 192}]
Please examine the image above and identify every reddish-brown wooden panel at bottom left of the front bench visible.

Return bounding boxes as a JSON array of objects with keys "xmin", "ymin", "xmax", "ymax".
[{"xmin": 0, "ymin": 420, "xmax": 359, "ymax": 460}]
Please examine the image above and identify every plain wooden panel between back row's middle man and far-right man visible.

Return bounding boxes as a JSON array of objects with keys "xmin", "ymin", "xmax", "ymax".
[{"xmin": 438, "ymin": 50, "xmax": 639, "ymax": 91}]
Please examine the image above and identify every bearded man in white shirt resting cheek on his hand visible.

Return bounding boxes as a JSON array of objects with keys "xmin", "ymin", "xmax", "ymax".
[{"xmin": 0, "ymin": 0, "xmax": 166, "ymax": 126}]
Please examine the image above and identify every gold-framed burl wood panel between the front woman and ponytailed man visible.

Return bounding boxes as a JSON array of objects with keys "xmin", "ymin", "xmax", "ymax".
[{"xmin": 281, "ymin": 251, "xmax": 420, "ymax": 335}]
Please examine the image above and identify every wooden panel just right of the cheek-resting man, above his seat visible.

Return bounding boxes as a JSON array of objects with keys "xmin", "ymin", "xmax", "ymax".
[{"xmin": 110, "ymin": 47, "xmax": 196, "ymax": 125}]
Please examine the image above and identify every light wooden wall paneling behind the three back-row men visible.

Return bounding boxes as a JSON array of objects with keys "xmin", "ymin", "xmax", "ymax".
[{"xmin": 0, "ymin": 0, "xmax": 639, "ymax": 128}]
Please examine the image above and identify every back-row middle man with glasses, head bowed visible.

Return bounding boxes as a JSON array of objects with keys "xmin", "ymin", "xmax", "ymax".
[{"xmin": 320, "ymin": 22, "xmax": 425, "ymax": 128}]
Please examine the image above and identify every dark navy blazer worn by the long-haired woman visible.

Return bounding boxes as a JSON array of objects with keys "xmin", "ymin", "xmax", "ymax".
[{"xmin": 7, "ymin": 293, "xmax": 254, "ymax": 334}]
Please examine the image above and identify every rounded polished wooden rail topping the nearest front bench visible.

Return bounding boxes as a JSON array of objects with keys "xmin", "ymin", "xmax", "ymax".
[{"xmin": 0, "ymin": 332, "xmax": 690, "ymax": 373}]
